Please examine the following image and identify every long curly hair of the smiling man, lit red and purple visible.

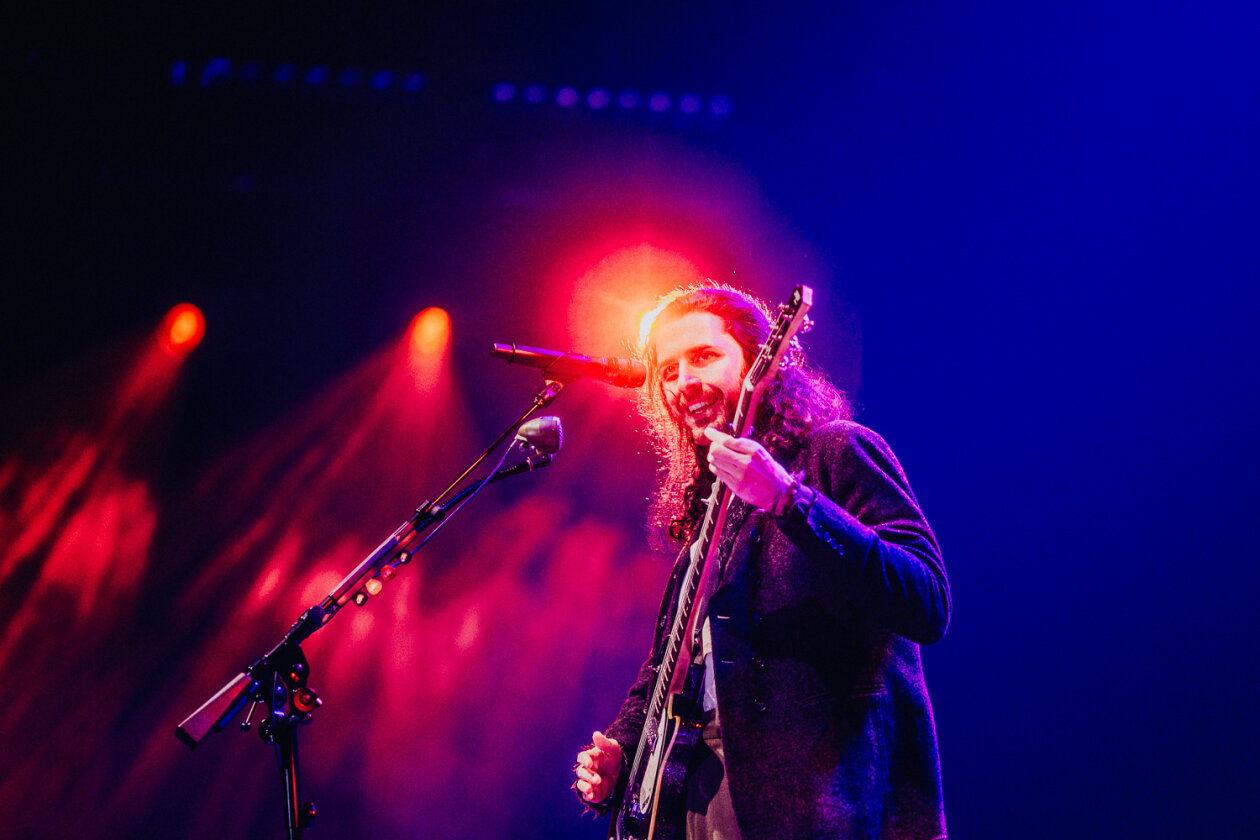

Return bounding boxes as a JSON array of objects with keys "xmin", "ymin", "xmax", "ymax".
[{"xmin": 639, "ymin": 282, "xmax": 852, "ymax": 548}]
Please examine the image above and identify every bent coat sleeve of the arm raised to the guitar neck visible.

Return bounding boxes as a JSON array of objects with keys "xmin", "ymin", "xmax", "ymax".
[{"xmin": 779, "ymin": 423, "xmax": 953, "ymax": 645}]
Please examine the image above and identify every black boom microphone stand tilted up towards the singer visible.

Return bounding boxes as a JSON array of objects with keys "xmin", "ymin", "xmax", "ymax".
[{"xmin": 175, "ymin": 379, "xmax": 567, "ymax": 840}]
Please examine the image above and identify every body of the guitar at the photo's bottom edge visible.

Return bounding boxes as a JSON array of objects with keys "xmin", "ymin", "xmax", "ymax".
[{"xmin": 609, "ymin": 665, "xmax": 704, "ymax": 840}]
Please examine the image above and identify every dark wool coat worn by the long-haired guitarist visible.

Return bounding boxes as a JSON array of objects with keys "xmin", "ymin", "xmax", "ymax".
[{"xmin": 606, "ymin": 422, "xmax": 950, "ymax": 840}]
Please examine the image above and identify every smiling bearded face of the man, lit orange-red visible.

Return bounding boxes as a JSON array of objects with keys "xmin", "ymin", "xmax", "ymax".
[{"xmin": 656, "ymin": 311, "xmax": 746, "ymax": 446}]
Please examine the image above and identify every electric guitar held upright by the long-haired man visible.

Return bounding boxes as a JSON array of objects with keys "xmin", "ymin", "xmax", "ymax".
[{"xmin": 609, "ymin": 286, "xmax": 813, "ymax": 840}]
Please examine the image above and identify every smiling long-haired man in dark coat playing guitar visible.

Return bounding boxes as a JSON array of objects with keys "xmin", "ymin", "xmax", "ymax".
[{"xmin": 575, "ymin": 288, "xmax": 951, "ymax": 840}]
